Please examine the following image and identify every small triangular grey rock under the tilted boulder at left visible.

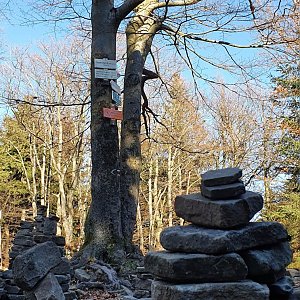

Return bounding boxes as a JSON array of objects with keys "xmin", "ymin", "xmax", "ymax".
[{"xmin": 33, "ymin": 273, "xmax": 65, "ymax": 300}]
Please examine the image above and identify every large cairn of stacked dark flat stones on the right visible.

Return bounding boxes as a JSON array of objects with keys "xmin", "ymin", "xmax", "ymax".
[{"xmin": 145, "ymin": 168, "xmax": 293, "ymax": 300}]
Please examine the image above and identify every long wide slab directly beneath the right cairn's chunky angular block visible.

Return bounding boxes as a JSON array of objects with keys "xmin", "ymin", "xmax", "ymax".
[{"xmin": 160, "ymin": 222, "xmax": 289, "ymax": 254}]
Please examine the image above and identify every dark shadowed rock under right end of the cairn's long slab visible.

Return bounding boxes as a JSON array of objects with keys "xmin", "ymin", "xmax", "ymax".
[{"xmin": 241, "ymin": 242, "xmax": 292, "ymax": 283}]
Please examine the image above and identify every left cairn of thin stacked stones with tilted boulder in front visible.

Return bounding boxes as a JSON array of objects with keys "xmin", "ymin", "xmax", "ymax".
[{"xmin": 0, "ymin": 206, "xmax": 77, "ymax": 300}]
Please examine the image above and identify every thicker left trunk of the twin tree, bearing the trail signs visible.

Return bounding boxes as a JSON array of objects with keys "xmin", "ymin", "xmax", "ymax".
[{"xmin": 83, "ymin": 0, "xmax": 122, "ymax": 259}]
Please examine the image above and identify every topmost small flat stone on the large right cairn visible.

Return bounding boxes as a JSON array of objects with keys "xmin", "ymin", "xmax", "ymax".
[{"xmin": 201, "ymin": 168, "xmax": 242, "ymax": 186}]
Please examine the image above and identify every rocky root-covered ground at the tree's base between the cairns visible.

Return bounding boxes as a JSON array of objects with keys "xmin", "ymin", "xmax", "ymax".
[{"xmin": 71, "ymin": 255, "xmax": 300, "ymax": 300}]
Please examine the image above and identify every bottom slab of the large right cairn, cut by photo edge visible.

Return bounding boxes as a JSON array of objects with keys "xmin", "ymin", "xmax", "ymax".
[{"xmin": 151, "ymin": 280, "xmax": 269, "ymax": 300}]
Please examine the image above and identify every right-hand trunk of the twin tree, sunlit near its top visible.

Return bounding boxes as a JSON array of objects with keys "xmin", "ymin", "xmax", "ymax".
[{"xmin": 120, "ymin": 10, "xmax": 159, "ymax": 253}]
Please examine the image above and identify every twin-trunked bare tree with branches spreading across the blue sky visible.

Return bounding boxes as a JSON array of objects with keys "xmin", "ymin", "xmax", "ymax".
[{"xmin": 11, "ymin": 0, "xmax": 293, "ymax": 259}]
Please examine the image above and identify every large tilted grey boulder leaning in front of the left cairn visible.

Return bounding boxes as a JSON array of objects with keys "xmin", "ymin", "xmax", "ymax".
[{"xmin": 12, "ymin": 242, "xmax": 61, "ymax": 290}]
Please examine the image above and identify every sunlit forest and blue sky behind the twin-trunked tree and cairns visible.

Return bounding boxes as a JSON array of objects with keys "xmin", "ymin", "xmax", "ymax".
[{"xmin": 0, "ymin": 1, "xmax": 300, "ymax": 268}]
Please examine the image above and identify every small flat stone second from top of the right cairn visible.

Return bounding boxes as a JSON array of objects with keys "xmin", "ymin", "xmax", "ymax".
[{"xmin": 201, "ymin": 181, "xmax": 246, "ymax": 200}]
